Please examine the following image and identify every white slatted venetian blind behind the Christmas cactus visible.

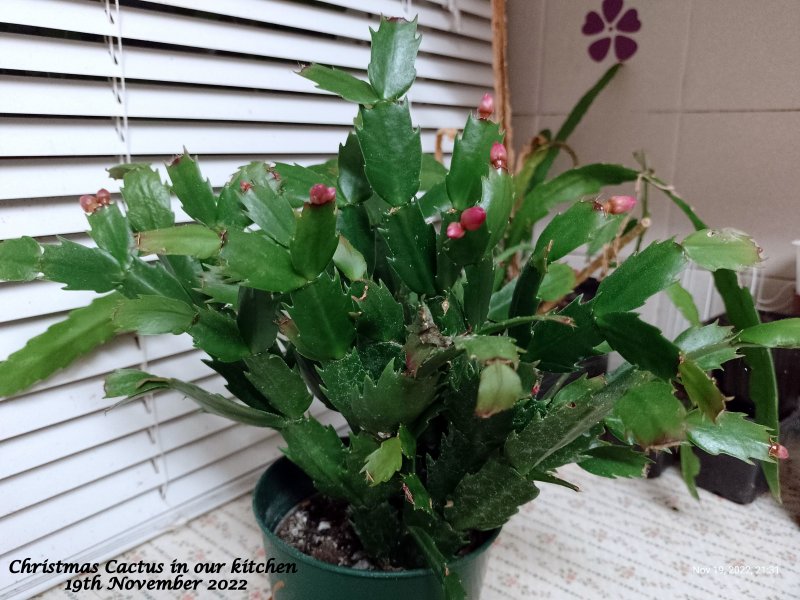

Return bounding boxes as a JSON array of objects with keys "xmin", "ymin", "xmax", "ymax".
[{"xmin": 0, "ymin": 0, "xmax": 493, "ymax": 599}]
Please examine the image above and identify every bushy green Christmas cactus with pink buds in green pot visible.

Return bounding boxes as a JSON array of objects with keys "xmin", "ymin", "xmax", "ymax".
[{"xmin": 0, "ymin": 19, "xmax": 800, "ymax": 598}]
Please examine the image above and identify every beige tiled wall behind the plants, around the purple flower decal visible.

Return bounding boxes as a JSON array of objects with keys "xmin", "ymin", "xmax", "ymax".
[{"xmin": 508, "ymin": 0, "xmax": 800, "ymax": 279}]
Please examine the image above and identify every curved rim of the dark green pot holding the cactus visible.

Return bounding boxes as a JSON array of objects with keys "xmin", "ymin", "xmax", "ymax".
[{"xmin": 252, "ymin": 456, "xmax": 501, "ymax": 579}]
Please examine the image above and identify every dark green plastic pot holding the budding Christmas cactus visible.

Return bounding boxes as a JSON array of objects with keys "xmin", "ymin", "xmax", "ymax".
[{"xmin": 253, "ymin": 457, "xmax": 500, "ymax": 600}]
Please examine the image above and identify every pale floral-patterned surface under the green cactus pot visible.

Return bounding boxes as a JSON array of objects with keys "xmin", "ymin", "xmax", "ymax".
[{"xmin": 41, "ymin": 444, "xmax": 800, "ymax": 600}]
